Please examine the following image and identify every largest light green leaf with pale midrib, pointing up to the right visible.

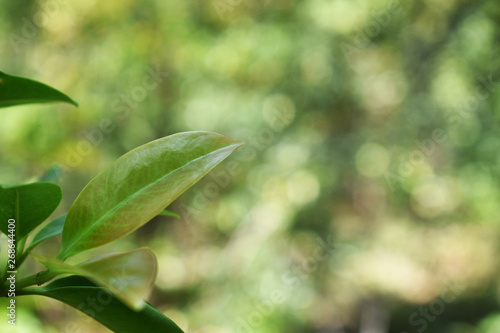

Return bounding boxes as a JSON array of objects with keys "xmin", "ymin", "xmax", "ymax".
[{"xmin": 58, "ymin": 132, "xmax": 241, "ymax": 259}]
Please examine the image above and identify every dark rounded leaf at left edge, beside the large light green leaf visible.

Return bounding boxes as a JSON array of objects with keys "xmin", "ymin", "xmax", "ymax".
[{"xmin": 0, "ymin": 183, "xmax": 62, "ymax": 240}]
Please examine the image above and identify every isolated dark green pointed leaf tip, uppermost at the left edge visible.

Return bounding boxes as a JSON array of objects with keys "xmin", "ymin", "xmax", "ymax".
[{"xmin": 0, "ymin": 72, "xmax": 78, "ymax": 108}]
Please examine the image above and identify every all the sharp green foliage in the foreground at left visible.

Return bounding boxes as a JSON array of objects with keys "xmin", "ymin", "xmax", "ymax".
[{"xmin": 0, "ymin": 73, "xmax": 240, "ymax": 332}]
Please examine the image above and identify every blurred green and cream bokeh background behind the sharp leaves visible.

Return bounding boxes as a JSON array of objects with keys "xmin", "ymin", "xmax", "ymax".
[{"xmin": 0, "ymin": 0, "xmax": 500, "ymax": 333}]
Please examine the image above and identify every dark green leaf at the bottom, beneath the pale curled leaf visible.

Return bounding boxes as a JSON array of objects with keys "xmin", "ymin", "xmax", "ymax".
[{"xmin": 17, "ymin": 276, "xmax": 183, "ymax": 333}]
